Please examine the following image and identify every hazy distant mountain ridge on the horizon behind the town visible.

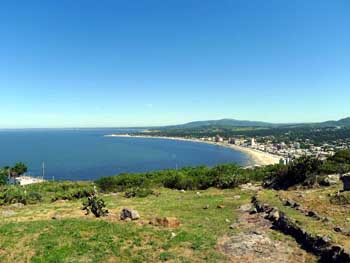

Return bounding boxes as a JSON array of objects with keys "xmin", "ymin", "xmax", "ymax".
[{"xmin": 167, "ymin": 117, "xmax": 350, "ymax": 129}]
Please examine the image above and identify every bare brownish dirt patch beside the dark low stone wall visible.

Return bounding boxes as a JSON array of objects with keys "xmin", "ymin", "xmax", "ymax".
[{"xmin": 218, "ymin": 205, "xmax": 316, "ymax": 263}]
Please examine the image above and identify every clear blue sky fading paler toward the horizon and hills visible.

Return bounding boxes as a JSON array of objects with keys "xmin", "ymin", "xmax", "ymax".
[{"xmin": 0, "ymin": 0, "xmax": 350, "ymax": 128}]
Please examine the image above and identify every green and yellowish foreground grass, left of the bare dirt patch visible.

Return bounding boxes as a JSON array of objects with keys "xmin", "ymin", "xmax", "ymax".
[{"xmin": 0, "ymin": 189, "xmax": 251, "ymax": 262}]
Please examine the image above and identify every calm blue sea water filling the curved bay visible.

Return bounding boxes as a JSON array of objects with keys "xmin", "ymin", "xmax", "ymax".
[{"xmin": 0, "ymin": 129, "xmax": 251, "ymax": 180}]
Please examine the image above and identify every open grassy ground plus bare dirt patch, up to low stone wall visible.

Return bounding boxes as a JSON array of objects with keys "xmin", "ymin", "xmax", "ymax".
[{"xmin": 0, "ymin": 187, "xmax": 316, "ymax": 262}]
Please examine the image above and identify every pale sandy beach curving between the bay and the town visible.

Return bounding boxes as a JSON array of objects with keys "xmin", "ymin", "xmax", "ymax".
[{"xmin": 104, "ymin": 134, "xmax": 281, "ymax": 166}]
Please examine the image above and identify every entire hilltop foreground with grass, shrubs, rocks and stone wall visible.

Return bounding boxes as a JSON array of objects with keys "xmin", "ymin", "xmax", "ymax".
[{"xmin": 0, "ymin": 151, "xmax": 350, "ymax": 263}]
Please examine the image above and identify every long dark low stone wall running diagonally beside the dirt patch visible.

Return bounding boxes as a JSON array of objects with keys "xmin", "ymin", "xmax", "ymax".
[{"xmin": 252, "ymin": 197, "xmax": 350, "ymax": 263}]
